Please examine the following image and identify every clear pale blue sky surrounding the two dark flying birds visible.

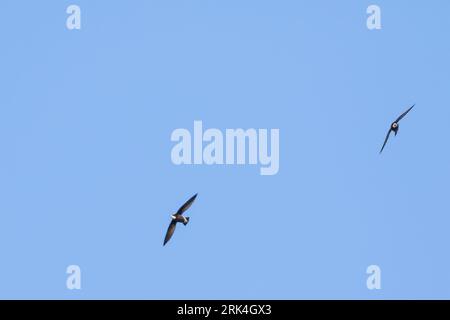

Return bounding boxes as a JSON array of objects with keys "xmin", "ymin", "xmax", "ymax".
[{"xmin": 0, "ymin": 0, "xmax": 450, "ymax": 299}]
